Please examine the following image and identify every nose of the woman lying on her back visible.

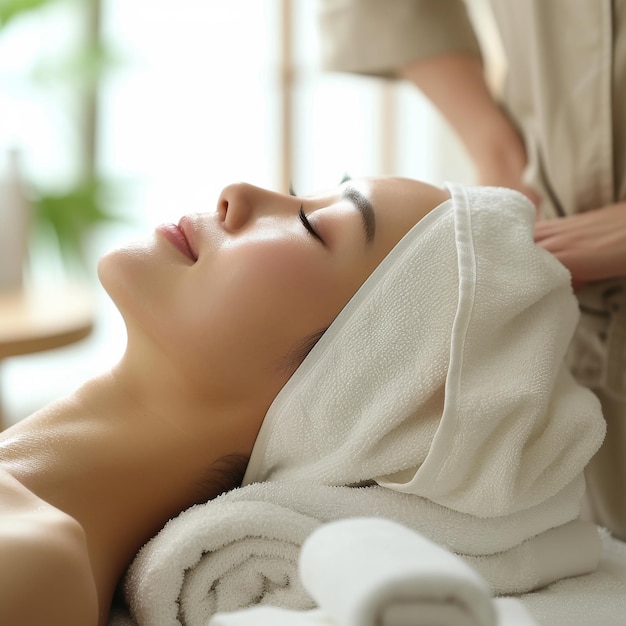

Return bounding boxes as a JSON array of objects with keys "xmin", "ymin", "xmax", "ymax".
[{"xmin": 217, "ymin": 183, "xmax": 300, "ymax": 232}]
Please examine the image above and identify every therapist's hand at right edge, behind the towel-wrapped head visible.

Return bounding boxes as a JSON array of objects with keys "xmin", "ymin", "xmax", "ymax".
[{"xmin": 535, "ymin": 202, "xmax": 626, "ymax": 289}]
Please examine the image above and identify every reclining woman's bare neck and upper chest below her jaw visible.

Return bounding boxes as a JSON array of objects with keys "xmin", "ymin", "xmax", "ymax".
[{"xmin": 0, "ymin": 362, "xmax": 256, "ymax": 616}]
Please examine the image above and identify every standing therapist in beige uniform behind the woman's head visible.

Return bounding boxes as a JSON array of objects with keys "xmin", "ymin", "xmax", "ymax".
[{"xmin": 319, "ymin": 0, "xmax": 626, "ymax": 539}]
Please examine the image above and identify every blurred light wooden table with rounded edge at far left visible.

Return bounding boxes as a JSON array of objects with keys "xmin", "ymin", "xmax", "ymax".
[{"xmin": 0, "ymin": 285, "xmax": 94, "ymax": 430}]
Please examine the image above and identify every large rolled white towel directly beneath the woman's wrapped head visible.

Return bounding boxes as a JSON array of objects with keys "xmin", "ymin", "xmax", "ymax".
[{"xmin": 123, "ymin": 481, "xmax": 598, "ymax": 626}]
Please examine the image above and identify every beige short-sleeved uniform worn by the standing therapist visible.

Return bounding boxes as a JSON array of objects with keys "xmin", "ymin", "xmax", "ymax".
[{"xmin": 320, "ymin": 0, "xmax": 626, "ymax": 539}]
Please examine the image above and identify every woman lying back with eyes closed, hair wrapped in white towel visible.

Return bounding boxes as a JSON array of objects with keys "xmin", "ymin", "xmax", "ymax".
[{"xmin": 0, "ymin": 178, "xmax": 604, "ymax": 626}]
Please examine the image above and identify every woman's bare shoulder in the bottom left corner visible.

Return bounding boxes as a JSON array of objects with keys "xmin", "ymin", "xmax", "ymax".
[{"xmin": 0, "ymin": 469, "xmax": 98, "ymax": 626}]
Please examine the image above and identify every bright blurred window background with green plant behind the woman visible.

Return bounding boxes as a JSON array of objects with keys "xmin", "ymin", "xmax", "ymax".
[{"xmin": 0, "ymin": 0, "xmax": 498, "ymax": 423}]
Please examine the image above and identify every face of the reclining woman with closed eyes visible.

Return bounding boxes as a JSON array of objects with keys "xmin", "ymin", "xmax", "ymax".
[{"xmin": 99, "ymin": 177, "xmax": 448, "ymax": 406}]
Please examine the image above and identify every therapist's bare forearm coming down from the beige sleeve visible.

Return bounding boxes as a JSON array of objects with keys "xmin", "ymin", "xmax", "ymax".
[{"xmin": 398, "ymin": 53, "xmax": 526, "ymax": 195}]
